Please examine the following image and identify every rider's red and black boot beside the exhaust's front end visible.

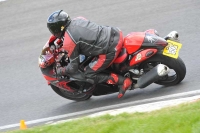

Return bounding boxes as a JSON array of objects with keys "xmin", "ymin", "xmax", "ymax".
[{"xmin": 118, "ymin": 78, "xmax": 132, "ymax": 98}]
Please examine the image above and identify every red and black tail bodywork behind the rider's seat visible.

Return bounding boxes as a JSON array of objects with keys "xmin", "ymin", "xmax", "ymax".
[{"xmin": 113, "ymin": 29, "xmax": 168, "ymax": 74}]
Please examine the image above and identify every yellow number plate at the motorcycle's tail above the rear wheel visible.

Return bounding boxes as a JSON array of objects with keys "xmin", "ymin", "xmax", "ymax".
[{"xmin": 163, "ymin": 40, "xmax": 182, "ymax": 59}]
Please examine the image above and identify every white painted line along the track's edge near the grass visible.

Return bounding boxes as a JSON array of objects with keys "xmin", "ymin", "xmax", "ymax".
[{"xmin": 0, "ymin": 90, "xmax": 200, "ymax": 130}]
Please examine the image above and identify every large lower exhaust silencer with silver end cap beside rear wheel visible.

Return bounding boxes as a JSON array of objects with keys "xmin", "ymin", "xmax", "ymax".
[{"xmin": 133, "ymin": 64, "xmax": 169, "ymax": 88}]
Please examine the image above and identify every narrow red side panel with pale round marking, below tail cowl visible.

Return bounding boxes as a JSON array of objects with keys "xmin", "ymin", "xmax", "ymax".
[{"xmin": 129, "ymin": 49, "xmax": 158, "ymax": 66}]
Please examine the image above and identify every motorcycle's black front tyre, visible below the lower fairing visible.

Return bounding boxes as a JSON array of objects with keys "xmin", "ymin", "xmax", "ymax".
[{"xmin": 50, "ymin": 85, "xmax": 92, "ymax": 102}]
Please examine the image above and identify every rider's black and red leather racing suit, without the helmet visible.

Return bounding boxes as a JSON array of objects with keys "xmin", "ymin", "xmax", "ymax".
[{"xmin": 62, "ymin": 18, "xmax": 124, "ymax": 84}]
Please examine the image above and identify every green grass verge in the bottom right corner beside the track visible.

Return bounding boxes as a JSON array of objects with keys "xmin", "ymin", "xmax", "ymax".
[{"xmin": 9, "ymin": 101, "xmax": 200, "ymax": 133}]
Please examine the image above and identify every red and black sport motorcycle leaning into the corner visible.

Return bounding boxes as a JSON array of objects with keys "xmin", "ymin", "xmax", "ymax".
[{"xmin": 39, "ymin": 29, "xmax": 186, "ymax": 101}]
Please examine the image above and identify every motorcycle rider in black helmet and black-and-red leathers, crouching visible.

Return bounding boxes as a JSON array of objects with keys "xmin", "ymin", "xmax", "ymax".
[{"xmin": 47, "ymin": 10, "xmax": 132, "ymax": 98}]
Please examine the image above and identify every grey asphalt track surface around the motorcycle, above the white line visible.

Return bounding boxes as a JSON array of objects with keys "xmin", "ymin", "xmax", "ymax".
[{"xmin": 0, "ymin": 0, "xmax": 200, "ymax": 131}]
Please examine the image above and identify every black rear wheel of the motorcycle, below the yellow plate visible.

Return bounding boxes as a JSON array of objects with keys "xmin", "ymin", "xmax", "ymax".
[{"xmin": 140, "ymin": 53, "xmax": 186, "ymax": 86}]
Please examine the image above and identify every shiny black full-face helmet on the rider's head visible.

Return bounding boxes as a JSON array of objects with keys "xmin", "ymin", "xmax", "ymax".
[{"xmin": 47, "ymin": 10, "xmax": 71, "ymax": 38}]
